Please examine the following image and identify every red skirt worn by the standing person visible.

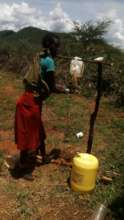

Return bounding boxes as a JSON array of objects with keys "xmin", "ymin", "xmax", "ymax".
[{"xmin": 15, "ymin": 92, "xmax": 46, "ymax": 150}]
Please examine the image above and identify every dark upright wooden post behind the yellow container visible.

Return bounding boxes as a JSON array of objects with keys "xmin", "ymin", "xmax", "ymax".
[{"xmin": 87, "ymin": 63, "xmax": 102, "ymax": 153}]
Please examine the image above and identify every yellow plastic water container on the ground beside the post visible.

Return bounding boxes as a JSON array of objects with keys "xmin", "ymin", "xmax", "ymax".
[{"xmin": 71, "ymin": 153, "xmax": 99, "ymax": 192}]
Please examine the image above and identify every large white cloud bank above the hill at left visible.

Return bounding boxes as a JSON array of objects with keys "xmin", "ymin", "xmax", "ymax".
[{"xmin": 0, "ymin": 2, "xmax": 73, "ymax": 32}]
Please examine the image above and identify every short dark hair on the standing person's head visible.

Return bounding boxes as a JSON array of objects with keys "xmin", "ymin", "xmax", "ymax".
[{"xmin": 42, "ymin": 33, "xmax": 60, "ymax": 48}]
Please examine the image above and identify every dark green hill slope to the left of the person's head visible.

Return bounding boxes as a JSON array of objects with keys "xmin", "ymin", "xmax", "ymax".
[{"xmin": 0, "ymin": 27, "xmax": 54, "ymax": 72}]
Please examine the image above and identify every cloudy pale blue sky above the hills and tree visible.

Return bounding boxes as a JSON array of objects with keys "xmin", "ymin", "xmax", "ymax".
[{"xmin": 0, "ymin": 0, "xmax": 124, "ymax": 49}]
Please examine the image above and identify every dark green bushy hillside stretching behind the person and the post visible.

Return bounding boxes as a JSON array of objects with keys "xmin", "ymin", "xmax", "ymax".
[{"xmin": 0, "ymin": 27, "xmax": 124, "ymax": 106}]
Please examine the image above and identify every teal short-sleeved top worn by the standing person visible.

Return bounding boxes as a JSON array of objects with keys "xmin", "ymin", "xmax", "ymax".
[{"xmin": 40, "ymin": 56, "xmax": 55, "ymax": 80}]
